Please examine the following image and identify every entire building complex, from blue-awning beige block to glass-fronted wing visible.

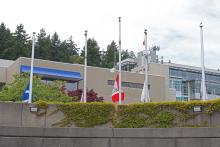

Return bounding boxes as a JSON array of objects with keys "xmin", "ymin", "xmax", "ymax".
[{"xmin": 0, "ymin": 54, "xmax": 220, "ymax": 103}]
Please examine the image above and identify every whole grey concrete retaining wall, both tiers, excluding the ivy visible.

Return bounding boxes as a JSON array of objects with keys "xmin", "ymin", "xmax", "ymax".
[{"xmin": 0, "ymin": 102, "xmax": 220, "ymax": 147}]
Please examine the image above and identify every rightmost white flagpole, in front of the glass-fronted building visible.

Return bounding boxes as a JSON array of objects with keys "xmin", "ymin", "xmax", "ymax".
[{"xmin": 200, "ymin": 23, "xmax": 207, "ymax": 101}]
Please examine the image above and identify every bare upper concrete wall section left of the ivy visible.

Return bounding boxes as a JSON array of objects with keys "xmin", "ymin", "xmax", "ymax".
[{"xmin": 0, "ymin": 102, "xmax": 67, "ymax": 127}]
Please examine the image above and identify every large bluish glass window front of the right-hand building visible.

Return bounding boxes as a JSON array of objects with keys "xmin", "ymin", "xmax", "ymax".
[{"xmin": 169, "ymin": 67, "xmax": 220, "ymax": 100}]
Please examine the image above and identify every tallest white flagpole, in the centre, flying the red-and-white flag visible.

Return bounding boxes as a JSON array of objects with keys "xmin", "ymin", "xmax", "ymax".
[{"xmin": 118, "ymin": 17, "xmax": 121, "ymax": 105}]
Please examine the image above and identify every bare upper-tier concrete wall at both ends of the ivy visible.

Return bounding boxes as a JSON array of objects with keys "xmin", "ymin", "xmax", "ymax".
[{"xmin": 0, "ymin": 102, "xmax": 220, "ymax": 128}]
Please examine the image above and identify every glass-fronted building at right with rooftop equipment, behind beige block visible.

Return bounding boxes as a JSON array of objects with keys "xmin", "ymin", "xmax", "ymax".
[{"xmin": 131, "ymin": 48, "xmax": 220, "ymax": 101}]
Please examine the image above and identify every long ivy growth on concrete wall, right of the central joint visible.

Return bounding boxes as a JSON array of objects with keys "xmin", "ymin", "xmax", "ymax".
[{"xmin": 113, "ymin": 99, "xmax": 220, "ymax": 128}]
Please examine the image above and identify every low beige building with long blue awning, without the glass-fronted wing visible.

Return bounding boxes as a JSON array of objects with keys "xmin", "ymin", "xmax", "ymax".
[{"xmin": 0, "ymin": 57, "xmax": 175, "ymax": 103}]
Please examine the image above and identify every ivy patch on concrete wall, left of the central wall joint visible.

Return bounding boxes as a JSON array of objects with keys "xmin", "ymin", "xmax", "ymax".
[{"xmin": 54, "ymin": 102, "xmax": 114, "ymax": 127}]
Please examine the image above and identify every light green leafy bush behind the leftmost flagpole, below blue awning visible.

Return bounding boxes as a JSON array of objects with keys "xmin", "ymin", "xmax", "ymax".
[{"xmin": 0, "ymin": 73, "xmax": 72, "ymax": 102}]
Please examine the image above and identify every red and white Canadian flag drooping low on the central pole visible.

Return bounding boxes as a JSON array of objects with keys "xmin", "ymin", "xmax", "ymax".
[{"xmin": 112, "ymin": 74, "xmax": 124, "ymax": 103}]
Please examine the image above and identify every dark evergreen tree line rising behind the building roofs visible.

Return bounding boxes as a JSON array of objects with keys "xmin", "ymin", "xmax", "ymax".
[{"xmin": 0, "ymin": 23, "xmax": 135, "ymax": 68}]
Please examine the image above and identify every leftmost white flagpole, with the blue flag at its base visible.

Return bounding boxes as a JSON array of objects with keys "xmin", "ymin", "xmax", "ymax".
[{"xmin": 28, "ymin": 32, "xmax": 35, "ymax": 103}]
